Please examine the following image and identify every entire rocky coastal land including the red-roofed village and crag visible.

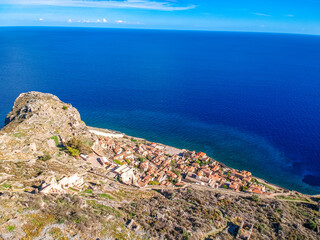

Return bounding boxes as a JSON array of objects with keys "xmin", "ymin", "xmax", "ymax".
[{"xmin": 0, "ymin": 92, "xmax": 320, "ymax": 240}]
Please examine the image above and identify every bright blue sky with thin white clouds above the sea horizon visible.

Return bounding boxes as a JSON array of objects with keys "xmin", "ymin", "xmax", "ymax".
[{"xmin": 0, "ymin": 0, "xmax": 320, "ymax": 35}]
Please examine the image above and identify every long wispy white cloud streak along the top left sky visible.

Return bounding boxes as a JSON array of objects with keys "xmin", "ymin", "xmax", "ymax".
[{"xmin": 0, "ymin": 0, "xmax": 196, "ymax": 11}]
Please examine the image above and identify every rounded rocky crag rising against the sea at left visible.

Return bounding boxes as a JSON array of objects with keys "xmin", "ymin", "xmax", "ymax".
[{"xmin": 5, "ymin": 92, "xmax": 88, "ymax": 137}]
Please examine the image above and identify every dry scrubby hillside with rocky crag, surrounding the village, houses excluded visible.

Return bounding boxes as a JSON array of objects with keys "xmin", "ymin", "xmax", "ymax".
[{"xmin": 0, "ymin": 92, "xmax": 320, "ymax": 240}]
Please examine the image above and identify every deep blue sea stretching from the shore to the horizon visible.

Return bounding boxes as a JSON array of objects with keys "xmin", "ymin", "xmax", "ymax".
[{"xmin": 0, "ymin": 27, "xmax": 320, "ymax": 194}]
